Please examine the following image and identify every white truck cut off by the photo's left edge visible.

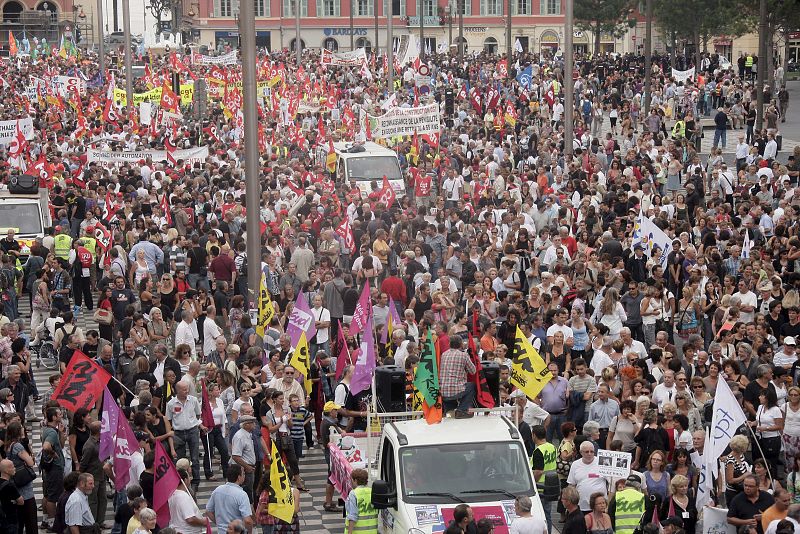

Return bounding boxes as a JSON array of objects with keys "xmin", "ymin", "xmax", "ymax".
[{"xmin": 0, "ymin": 188, "xmax": 53, "ymax": 263}]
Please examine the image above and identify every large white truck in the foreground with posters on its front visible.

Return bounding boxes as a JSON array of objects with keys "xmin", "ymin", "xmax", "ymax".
[{"xmin": 331, "ymin": 413, "xmax": 544, "ymax": 534}]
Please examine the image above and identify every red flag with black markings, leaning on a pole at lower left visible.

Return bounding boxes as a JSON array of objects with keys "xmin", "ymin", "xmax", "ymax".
[{"xmin": 52, "ymin": 350, "xmax": 111, "ymax": 412}]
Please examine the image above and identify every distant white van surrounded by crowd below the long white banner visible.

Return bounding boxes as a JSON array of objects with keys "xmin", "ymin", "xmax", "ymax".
[{"xmin": 333, "ymin": 142, "xmax": 406, "ymax": 198}]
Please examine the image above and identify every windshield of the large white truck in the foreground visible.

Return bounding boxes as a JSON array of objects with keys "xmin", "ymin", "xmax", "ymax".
[{"xmin": 400, "ymin": 441, "xmax": 533, "ymax": 503}]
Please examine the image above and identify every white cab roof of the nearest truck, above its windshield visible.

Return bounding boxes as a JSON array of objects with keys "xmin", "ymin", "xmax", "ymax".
[{"xmin": 386, "ymin": 415, "xmax": 516, "ymax": 446}]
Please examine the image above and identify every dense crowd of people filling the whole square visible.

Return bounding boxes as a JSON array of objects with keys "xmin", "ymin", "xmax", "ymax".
[{"xmin": 0, "ymin": 36, "xmax": 800, "ymax": 534}]
